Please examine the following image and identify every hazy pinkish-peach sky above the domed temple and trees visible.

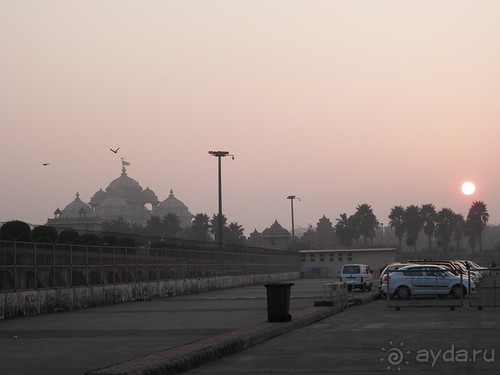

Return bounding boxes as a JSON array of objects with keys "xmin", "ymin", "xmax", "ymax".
[{"xmin": 0, "ymin": 0, "xmax": 500, "ymax": 235}]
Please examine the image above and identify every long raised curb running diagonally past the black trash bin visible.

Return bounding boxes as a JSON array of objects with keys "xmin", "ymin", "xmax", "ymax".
[{"xmin": 85, "ymin": 295, "xmax": 378, "ymax": 375}]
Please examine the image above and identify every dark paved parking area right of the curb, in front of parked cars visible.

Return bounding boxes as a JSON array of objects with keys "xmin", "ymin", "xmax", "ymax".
[{"xmin": 187, "ymin": 300, "xmax": 500, "ymax": 375}]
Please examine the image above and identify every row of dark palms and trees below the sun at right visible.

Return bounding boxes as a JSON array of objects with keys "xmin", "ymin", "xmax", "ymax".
[{"xmin": 298, "ymin": 201, "xmax": 489, "ymax": 251}]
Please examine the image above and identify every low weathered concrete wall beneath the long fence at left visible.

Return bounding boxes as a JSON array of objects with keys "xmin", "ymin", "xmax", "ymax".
[{"xmin": 0, "ymin": 272, "xmax": 300, "ymax": 319}]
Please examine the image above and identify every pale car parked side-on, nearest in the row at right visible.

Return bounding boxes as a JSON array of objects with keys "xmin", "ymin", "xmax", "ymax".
[{"xmin": 381, "ymin": 264, "xmax": 476, "ymax": 299}]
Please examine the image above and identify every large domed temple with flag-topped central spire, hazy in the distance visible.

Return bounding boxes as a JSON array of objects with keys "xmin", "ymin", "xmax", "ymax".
[{"xmin": 47, "ymin": 162, "xmax": 194, "ymax": 231}]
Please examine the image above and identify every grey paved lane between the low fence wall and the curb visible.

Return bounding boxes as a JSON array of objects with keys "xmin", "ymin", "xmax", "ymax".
[{"xmin": 0, "ymin": 280, "xmax": 348, "ymax": 375}]
